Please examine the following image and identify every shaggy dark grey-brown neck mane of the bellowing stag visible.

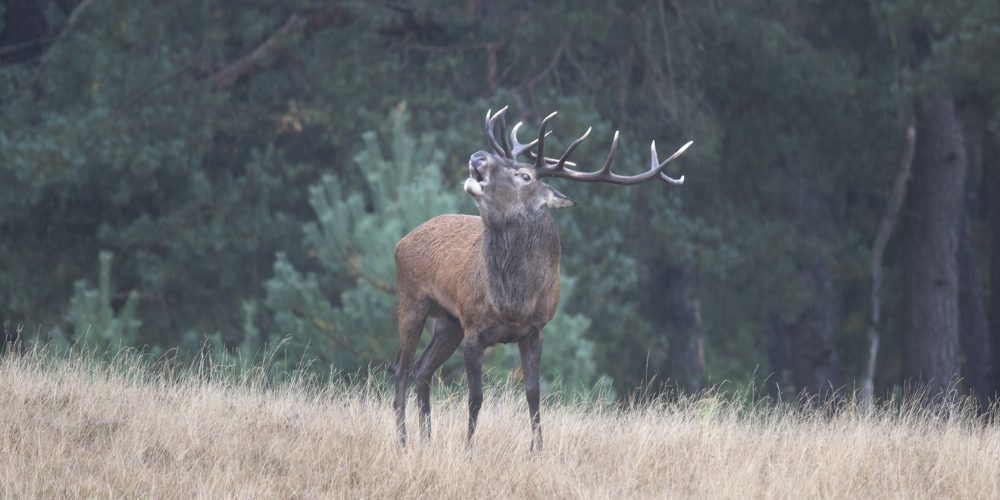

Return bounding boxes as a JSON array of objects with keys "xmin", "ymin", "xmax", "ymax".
[{"xmin": 483, "ymin": 210, "xmax": 560, "ymax": 318}]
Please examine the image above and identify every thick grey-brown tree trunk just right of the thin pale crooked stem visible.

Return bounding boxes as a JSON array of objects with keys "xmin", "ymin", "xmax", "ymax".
[{"xmin": 903, "ymin": 95, "xmax": 968, "ymax": 393}]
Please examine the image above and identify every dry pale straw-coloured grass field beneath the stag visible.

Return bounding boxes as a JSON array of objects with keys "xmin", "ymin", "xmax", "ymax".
[{"xmin": 0, "ymin": 354, "xmax": 1000, "ymax": 499}]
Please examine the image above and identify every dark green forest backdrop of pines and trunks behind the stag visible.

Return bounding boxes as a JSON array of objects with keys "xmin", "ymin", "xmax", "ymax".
[{"xmin": 0, "ymin": 0, "xmax": 1000, "ymax": 397}]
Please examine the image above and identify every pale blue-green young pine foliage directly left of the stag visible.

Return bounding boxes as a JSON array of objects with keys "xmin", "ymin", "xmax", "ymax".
[{"xmin": 265, "ymin": 106, "xmax": 459, "ymax": 371}]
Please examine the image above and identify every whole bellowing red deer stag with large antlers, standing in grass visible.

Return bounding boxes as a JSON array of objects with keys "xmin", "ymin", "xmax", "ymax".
[{"xmin": 393, "ymin": 108, "xmax": 691, "ymax": 450}]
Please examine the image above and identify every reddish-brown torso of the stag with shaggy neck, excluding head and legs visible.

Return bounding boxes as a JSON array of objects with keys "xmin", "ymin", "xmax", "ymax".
[{"xmin": 396, "ymin": 212, "xmax": 560, "ymax": 347}]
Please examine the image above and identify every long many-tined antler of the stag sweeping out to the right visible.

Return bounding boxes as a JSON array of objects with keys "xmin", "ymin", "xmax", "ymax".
[{"xmin": 512, "ymin": 108, "xmax": 694, "ymax": 185}]
